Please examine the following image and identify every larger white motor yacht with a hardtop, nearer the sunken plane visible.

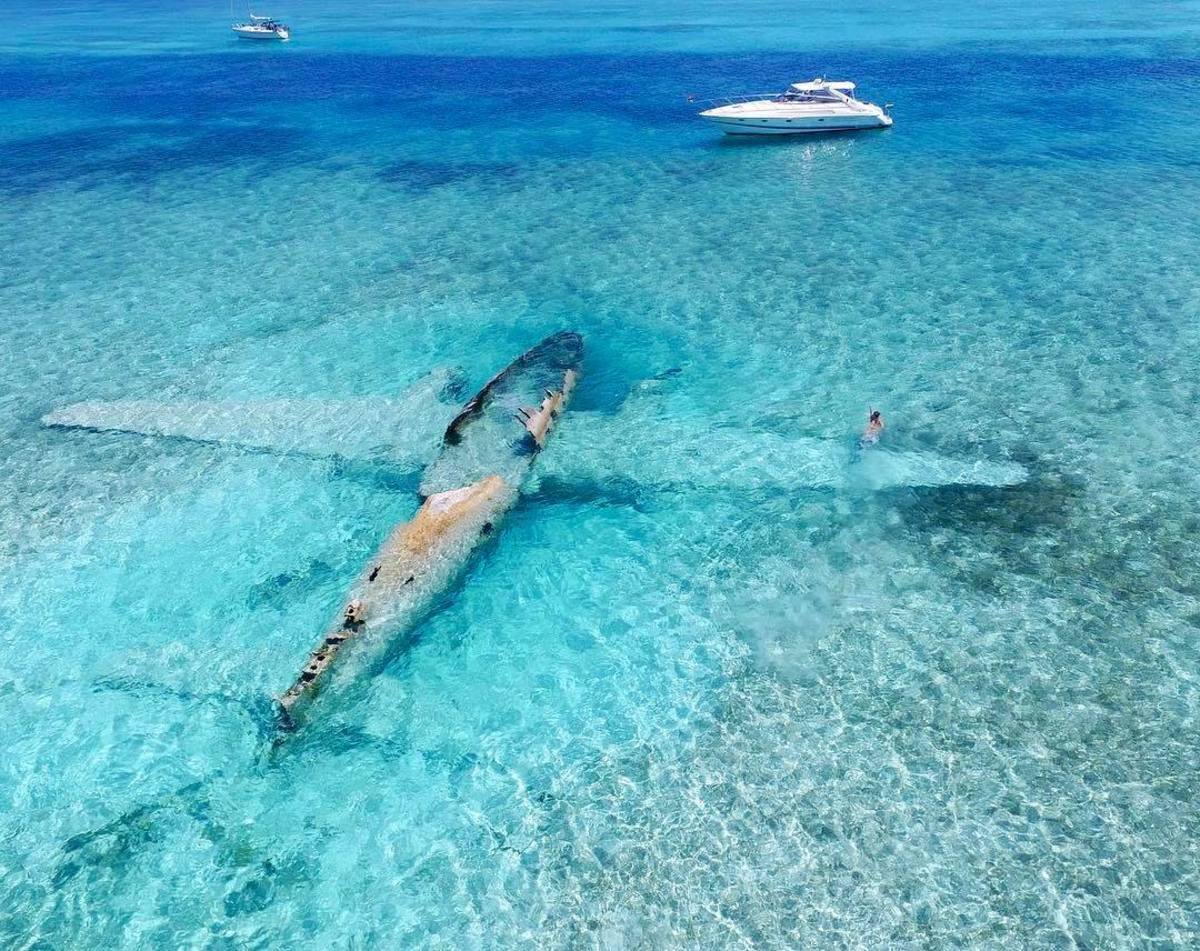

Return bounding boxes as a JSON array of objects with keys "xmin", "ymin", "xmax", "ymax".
[{"xmin": 701, "ymin": 79, "xmax": 892, "ymax": 136}]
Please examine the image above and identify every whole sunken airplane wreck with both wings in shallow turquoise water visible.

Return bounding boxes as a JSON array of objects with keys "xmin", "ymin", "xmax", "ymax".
[{"xmin": 42, "ymin": 331, "xmax": 1030, "ymax": 725}]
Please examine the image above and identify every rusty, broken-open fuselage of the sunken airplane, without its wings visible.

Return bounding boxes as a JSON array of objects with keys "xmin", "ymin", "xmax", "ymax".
[{"xmin": 280, "ymin": 331, "xmax": 583, "ymax": 725}]
